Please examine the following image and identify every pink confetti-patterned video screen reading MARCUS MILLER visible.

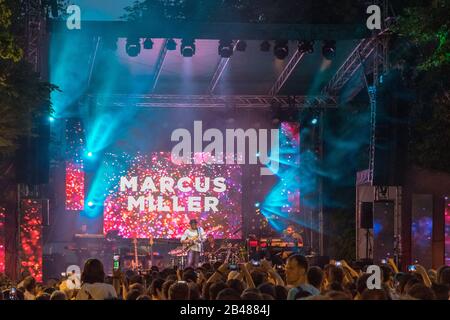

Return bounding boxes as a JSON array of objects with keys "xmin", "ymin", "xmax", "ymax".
[{"xmin": 103, "ymin": 152, "xmax": 242, "ymax": 239}]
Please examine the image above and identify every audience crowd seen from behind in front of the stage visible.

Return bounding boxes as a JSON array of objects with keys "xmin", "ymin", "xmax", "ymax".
[{"xmin": 0, "ymin": 254, "xmax": 450, "ymax": 300}]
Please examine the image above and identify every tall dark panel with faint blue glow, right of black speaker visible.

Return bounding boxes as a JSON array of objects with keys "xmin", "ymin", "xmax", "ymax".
[{"xmin": 373, "ymin": 200, "xmax": 395, "ymax": 263}]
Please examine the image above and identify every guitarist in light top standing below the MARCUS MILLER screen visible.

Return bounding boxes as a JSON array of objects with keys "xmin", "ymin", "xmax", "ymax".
[{"xmin": 181, "ymin": 219, "xmax": 205, "ymax": 268}]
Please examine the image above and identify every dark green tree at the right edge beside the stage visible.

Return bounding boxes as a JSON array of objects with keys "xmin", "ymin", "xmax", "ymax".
[{"xmin": 393, "ymin": 3, "xmax": 450, "ymax": 172}]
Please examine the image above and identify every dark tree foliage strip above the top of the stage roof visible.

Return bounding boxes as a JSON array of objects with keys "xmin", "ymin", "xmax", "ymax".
[{"xmin": 123, "ymin": 0, "xmax": 365, "ymax": 24}]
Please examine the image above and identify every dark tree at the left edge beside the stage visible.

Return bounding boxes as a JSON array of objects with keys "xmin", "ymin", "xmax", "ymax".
[{"xmin": 0, "ymin": 0, "xmax": 57, "ymax": 155}]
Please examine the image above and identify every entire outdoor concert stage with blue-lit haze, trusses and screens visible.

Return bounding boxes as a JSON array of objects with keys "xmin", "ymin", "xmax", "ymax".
[{"xmin": 0, "ymin": 34, "xmax": 450, "ymax": 280}]
